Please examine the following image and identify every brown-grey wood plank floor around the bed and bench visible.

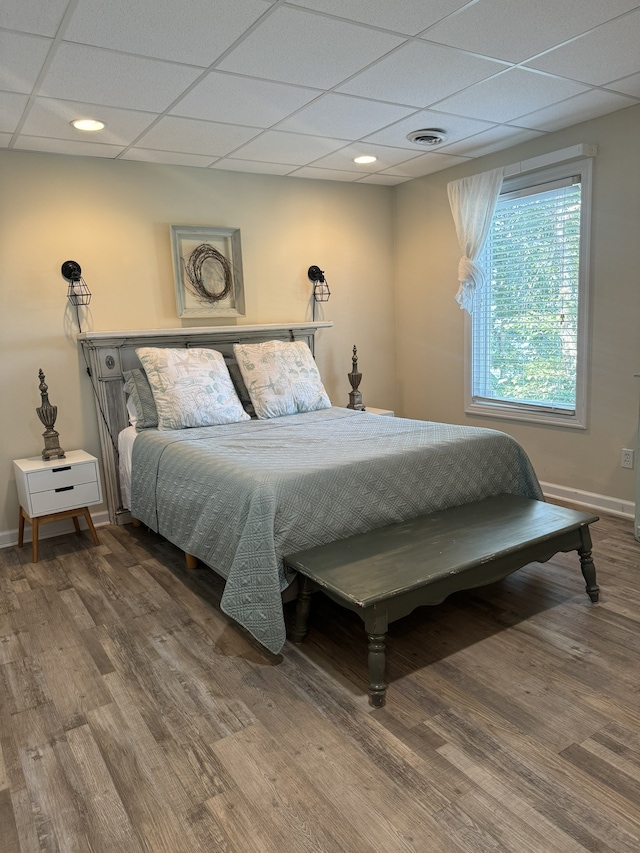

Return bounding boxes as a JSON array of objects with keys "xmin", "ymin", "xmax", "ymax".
[{"xmin": 0, "ymin": 510, "xmax": 640, "ymax": 853}]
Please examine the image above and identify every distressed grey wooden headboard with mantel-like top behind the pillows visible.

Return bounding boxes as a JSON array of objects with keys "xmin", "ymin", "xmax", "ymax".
[{"xmin": 78, "ymin": 321, "xmax": 333, "ymax": 524}]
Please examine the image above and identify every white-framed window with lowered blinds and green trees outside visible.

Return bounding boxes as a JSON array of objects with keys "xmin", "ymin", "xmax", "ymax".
[{"xmin": 466, "ymin": 160, "xmax": 591, "ymax": 428}]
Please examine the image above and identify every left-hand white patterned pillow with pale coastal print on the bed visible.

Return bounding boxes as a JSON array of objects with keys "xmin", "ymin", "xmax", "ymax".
[{"xmin": 136, "ymin": 347, "xmax": 250, "ymax": 429}]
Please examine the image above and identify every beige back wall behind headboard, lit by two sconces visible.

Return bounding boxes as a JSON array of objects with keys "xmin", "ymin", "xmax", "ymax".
[{"xmin": 0, "ymin": 151, "xmax": 396, "ymax": 544}]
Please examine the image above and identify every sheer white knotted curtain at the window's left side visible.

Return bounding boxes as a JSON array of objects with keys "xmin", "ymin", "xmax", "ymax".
[{"xmin": 447, "ymin": 167, "xmax": 504, "ymax": 314}]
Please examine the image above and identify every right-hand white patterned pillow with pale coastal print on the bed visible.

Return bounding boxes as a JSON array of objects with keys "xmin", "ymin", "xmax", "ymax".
[{"xmin": 233, "ymin": 341, "xmax": 331, "ymax": 420}]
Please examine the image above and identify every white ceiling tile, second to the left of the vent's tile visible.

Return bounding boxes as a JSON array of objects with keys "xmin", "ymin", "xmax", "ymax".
[{"xmin": 171, "ymin": 71, "xmax": 321, "ymax": 127}]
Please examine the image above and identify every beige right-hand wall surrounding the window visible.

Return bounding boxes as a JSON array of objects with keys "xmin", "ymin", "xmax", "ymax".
[{"xmin": 395, "ymin": 107, "xmax": 640, "ymax": 501}]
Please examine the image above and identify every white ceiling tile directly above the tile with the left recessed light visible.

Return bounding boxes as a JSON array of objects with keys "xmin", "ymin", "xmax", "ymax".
[{"xmin": 40, "ymin": 43, "xmax": 202, "ymax": 112}]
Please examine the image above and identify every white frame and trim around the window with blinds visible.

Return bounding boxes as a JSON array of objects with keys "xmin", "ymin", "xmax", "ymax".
[{"xmin": 464, "ymin": 157, "xmax": 593, "ymax": 429}]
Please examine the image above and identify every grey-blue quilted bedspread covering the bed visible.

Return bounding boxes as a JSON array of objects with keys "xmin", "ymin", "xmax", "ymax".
[{"xmin": 131, "ymin": 408, "xmax": 542, "ymax": 653}]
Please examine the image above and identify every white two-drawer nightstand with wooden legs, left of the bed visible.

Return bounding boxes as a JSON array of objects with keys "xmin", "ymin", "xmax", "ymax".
[{"xmin": 13, "ymin": 450, "xmax": 102, "ymax": 563}]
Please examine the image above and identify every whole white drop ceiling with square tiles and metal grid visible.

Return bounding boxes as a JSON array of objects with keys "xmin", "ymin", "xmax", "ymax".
[{"xmin": 0, "ymin": 0, "xmax": 640, "ymax": 180}]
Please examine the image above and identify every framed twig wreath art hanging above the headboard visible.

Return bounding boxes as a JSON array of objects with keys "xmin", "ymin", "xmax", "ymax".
[{"xmin": 171, "ymin": 225, "xmax": 245, "ymax": 318}]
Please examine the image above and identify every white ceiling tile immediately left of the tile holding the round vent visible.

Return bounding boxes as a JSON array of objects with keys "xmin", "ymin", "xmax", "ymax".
[{"xmin": 278, "ymin": 93, "xmax": 414, "ymax": 139}]
